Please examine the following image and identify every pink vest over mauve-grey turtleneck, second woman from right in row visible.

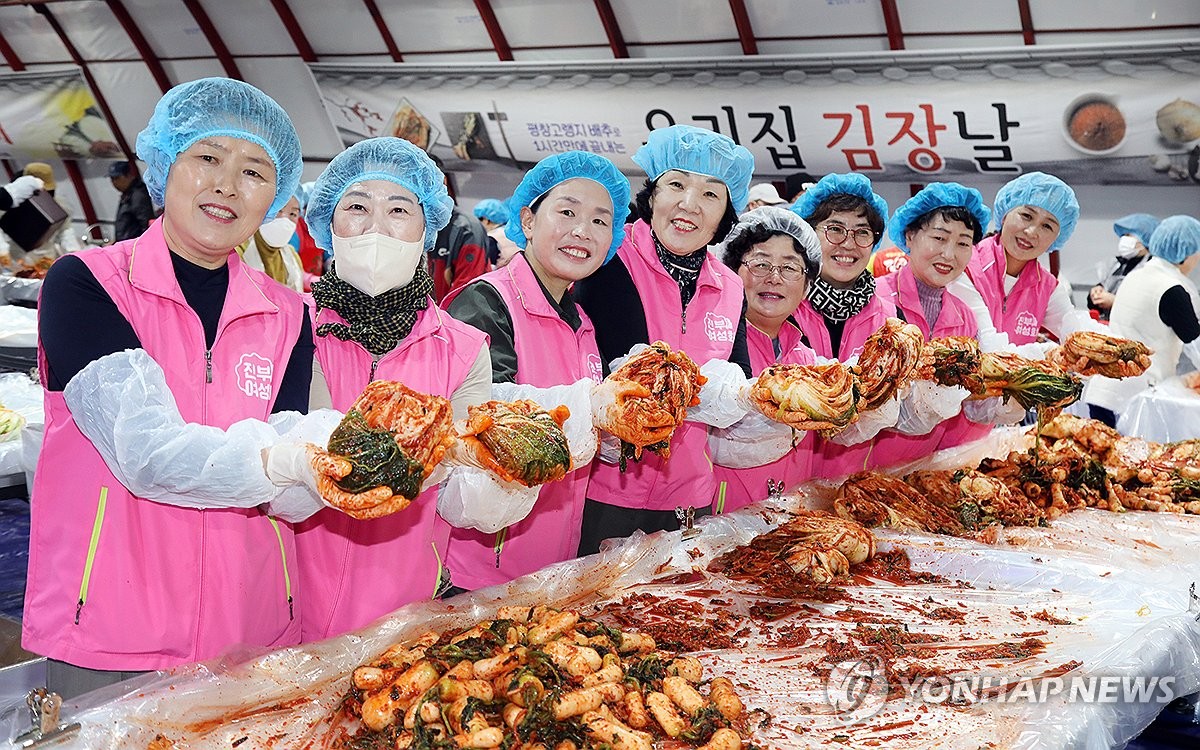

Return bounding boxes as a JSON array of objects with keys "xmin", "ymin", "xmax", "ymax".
[{"xmin": 868, "ymin": 265, "xmax": 991, "ymax": 467}]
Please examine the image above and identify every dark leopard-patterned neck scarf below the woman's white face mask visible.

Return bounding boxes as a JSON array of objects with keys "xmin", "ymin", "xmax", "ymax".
[{"xmin": 312, "ymin": 263, "xmax": 433, "ymax": 356}]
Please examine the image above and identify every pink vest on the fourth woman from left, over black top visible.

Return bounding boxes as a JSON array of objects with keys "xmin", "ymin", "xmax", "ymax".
[{"xmin": 588, "ymin": 221, "xmax": 745, "ymax": 510}]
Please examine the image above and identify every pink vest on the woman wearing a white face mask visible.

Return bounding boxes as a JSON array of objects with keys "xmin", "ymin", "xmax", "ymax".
[{"xmin": 296, "ymin": 300, "xmax": 487, "ymax": 642}]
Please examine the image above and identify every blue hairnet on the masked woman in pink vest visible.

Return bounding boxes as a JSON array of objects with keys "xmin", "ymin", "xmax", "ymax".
[{"xmin": 306, "ymin": 138, "xmax": 454, "ymax": 252}]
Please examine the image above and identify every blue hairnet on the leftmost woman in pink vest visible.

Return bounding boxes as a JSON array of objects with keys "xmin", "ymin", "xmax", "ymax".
[{"xmin": 137, "ymin": 78, "xmax": 304, "ymax": 216}]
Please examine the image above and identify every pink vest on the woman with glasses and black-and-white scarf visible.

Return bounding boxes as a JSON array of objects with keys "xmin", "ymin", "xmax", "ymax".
[{"xmin": 796, "ymin": 293, "xmax": 896, "ymax": 478}]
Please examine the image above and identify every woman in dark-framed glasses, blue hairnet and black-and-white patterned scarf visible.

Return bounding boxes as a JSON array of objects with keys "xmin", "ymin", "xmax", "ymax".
[{"xmin": 792, "ymin": 174, "xmax": 895, "ymax": 478}]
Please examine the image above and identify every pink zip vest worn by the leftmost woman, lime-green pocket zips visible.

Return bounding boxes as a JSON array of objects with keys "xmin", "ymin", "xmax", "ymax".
[{"xmin": 22, "ymin": 220, "xmax": 304, "ymax": 671}]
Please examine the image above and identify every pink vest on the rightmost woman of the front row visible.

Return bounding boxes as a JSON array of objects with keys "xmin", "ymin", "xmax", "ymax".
[{"xmin": 967, "ymin": 234, "xmax": 1058, "ymax": 344}]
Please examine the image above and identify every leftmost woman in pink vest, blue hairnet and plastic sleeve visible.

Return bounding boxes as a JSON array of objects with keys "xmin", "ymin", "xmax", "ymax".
[{"xmin": 22, "ymin": 78, "xmax": 312, "ymax": 696}]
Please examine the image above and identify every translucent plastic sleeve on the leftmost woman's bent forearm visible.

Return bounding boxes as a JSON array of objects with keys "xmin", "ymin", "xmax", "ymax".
[{"xmin": 62, "ymin": 349, "xmax": 278, "ymax": 508}]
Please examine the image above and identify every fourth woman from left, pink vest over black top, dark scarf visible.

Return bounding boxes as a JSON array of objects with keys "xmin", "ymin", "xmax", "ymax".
[{"xmin": 576, "ymin": 125, "xmax": 754, "ymax": 554}]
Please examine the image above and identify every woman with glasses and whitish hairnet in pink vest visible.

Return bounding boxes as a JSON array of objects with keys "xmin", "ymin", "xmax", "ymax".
[{"xmin": 714, "ymin": 205, "xmax": 821, "ymax": 512}]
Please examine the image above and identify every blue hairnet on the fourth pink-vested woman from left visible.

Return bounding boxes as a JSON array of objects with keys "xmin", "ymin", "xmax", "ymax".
[{"xmin": 634, "ymin": 125, "xmax": 754, "ymax": 214}]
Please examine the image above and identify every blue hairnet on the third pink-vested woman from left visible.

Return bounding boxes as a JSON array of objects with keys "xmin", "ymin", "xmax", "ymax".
[{"xmin": 504, "ymin": 151, "xmax": 629, "ymax": 263}]
